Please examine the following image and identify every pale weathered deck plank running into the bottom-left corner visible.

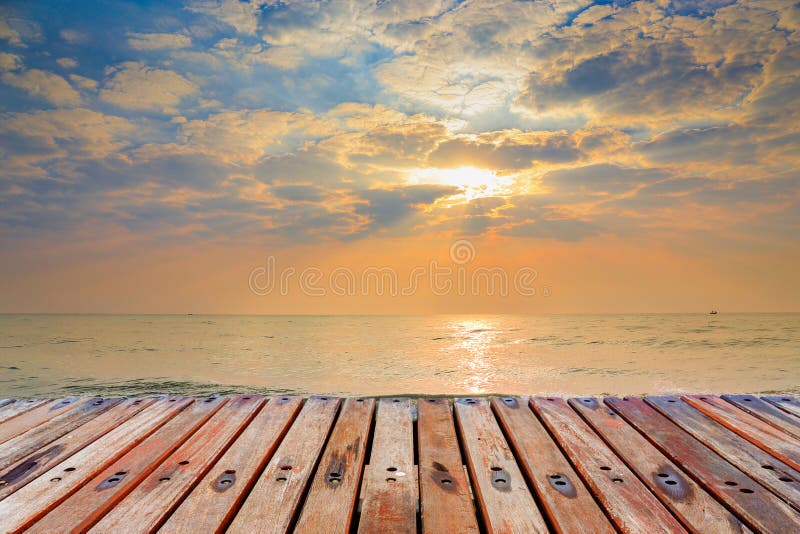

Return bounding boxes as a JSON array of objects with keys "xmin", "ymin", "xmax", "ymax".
[{"xmin": 0, "ymin": 397, "xmax": 192, "ymax": 532}]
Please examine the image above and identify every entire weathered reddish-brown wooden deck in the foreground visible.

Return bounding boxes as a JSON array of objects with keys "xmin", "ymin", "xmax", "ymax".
[{"xmin": 0, "ymin": 395, "xmax": 800, "ymax": 534}]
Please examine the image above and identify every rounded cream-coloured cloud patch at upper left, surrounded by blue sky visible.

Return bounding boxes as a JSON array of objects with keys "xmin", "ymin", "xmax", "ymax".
[{"xmin": 100, "ymin": 61, "xmax": 199, "ymax": 113}]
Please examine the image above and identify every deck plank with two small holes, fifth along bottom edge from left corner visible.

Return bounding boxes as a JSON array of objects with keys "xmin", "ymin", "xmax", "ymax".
[{"xmin": 228, "ymin": 397, "xmax": 339, "ymax": 534}]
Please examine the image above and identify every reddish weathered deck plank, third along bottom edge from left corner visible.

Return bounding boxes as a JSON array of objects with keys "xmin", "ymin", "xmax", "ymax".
[{"xmin": 90, "ymin": 395, "xmax": 264, "ymax": 532}]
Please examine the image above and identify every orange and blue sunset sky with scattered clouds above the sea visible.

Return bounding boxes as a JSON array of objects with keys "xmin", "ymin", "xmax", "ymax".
[{"xmin": 0, "ymin": 0, "xmax": 800, "ymax": 314}]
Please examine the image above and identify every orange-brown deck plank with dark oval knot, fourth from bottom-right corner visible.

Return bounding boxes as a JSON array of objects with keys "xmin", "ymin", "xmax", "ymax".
[{"xmin": 492, "ymin": 397, "xmax": 616, "ymax": 533}]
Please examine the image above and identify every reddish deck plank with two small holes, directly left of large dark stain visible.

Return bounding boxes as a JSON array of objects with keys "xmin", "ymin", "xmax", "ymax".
[{"xmin": 530, "ymin": 397, "xmax": 686, "ymax": 533}]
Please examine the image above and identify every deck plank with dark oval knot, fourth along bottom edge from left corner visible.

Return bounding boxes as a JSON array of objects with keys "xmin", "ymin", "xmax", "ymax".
[{"xmin": 159, "ymin": 397, "xmax": 303, "ymax": 534}]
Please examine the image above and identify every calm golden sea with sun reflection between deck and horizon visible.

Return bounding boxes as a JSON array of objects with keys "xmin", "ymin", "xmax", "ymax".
[{"xmin": 0, "ymin": 313, "xmax": 800, "ymax": 397}]
